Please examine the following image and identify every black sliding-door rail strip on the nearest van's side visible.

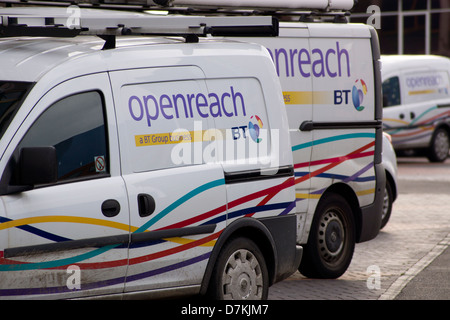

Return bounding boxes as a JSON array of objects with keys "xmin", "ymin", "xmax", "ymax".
[{"xmin": 225, "ymin": 165, "xmax": 294, "ymax": 184}]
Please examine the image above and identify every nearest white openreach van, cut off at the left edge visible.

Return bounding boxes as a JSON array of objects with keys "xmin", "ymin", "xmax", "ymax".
[{"xmin": 0, "ymin": 8, "xmax": 301, "ymax": 299}]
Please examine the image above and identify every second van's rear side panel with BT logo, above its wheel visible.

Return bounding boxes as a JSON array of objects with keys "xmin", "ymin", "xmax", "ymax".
[{"xmin": 310, "ymin": 29, "xmax": 379, "ymax": 210}]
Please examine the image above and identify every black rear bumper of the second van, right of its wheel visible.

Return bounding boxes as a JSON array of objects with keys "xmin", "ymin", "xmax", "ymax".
[{"xmin": 356, "ymin": 163, "xmax": 386, "ymax": 243}]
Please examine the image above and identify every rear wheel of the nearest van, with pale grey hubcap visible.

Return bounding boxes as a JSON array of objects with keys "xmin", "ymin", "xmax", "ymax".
[{"xmin": 208, "ymin": 237, "xmax": 269, "ymax": 300}]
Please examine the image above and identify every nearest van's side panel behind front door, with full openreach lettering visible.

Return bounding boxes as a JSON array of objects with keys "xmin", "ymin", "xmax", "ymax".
[{"xmin": 110, "ymin": 47, "xmax": 299, "ymax": 292}]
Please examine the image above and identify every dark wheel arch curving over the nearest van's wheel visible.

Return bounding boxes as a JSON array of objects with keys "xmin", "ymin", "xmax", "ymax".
[{"xmin": 200, "ymin": 217, "xmax": 277, "ymax": 295}]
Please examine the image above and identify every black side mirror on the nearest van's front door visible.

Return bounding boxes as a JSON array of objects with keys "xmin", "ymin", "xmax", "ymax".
[{"xmin": 16, "ymin": 147, "xmax": 58, "ymax": 186}]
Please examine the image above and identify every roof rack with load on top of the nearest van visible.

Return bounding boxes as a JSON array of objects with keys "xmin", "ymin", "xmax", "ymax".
[{"xmin": 0, "ymin": 7, "xmax": 278, "ymax": 49}]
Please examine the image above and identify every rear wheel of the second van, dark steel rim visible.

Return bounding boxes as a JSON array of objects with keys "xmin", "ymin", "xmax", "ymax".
[{"xmin": 299, "ymin": 194, "xmax": 355, "ymax": 279}]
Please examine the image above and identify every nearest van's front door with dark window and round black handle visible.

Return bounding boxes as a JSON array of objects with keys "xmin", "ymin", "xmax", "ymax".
[{"xmin": 0, "ymin": 74, "xmax": 129, "ymax": 298}]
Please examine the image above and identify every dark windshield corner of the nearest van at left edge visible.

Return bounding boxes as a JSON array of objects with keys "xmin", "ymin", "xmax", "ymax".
[{"xmin": 0, "ymin": 81, "xmax": 32, "ymax": 139}]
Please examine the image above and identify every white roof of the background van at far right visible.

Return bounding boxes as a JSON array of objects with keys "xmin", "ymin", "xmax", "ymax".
[{"xmin": 381, "ymin": 55, "xmax": 450, "ymax": 77}]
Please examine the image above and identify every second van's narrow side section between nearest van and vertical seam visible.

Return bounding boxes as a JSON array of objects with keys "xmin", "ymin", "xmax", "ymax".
[{"xmin": 238, "ymin": 28, "xmax": 313, "ymax": 232}]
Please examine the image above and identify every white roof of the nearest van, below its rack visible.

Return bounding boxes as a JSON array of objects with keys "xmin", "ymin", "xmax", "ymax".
[{"xmin": 0, "ymin": 36, "xmax": 261, "ymax": 82}]
